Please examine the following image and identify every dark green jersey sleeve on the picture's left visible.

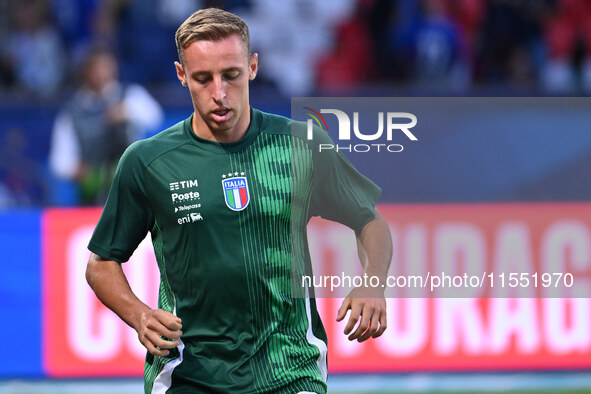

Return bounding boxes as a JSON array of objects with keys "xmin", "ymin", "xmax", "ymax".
[{"xmin": 88, "ymin": 142, "xmax": 154, "ymax": 263}]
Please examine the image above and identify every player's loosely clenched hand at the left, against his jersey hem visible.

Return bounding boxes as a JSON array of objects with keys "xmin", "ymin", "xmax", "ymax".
[{"xmin": 136, "ymin": 309, "xmax": 183, "ymax": 356}]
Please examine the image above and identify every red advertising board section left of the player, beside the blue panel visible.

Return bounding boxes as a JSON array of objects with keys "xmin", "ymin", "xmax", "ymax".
[{"xmin": 42, "ymin": 209, "xmax": 159, "ymax": 377}]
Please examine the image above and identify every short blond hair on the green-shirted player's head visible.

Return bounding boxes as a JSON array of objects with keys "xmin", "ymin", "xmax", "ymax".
[{"xmin": 174, "ymin": 8, "xmax": 250, "ymax": 63}]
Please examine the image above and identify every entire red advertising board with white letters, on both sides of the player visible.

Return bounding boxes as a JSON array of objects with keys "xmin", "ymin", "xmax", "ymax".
[{"xmin": 43, "ymin": 203, "xmax": 591, "ymax": 377}]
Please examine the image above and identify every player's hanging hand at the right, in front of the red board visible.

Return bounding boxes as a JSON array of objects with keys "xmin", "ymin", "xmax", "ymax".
[{"xmin": 337, "ymin": 289, "xmax": 387, "ymax": 342}]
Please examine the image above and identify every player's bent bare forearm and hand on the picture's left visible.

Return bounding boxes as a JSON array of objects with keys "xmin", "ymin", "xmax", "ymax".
[{"xmin": 86, "ymin": 253, "xmax": 183, "ymax": 356}]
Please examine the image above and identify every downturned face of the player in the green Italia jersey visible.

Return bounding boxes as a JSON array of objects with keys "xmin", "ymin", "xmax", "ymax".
[{"xmin": 175, "ymin": 35, "xmax": 258, "ymax": 142}]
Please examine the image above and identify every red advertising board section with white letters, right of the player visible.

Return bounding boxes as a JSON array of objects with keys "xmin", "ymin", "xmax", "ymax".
[{"xmin": 310, "ymin": 204, "xmax": 591, "ymax": 372}]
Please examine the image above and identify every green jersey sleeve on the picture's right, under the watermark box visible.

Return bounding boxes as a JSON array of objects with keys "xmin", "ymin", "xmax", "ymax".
[{"xmin": 310, "ymin": 129, "xmax": 382, "ymax": 234}]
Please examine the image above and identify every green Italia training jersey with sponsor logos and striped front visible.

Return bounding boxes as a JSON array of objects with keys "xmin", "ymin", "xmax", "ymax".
[{"xmin": 89, "ymin": 109, "xmax": 380, "ymax": 393}]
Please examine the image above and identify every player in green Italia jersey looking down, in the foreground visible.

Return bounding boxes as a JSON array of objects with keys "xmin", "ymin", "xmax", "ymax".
[{"xmin": 86, "ymin": 9, "xmax": 392, "ymax": 393}]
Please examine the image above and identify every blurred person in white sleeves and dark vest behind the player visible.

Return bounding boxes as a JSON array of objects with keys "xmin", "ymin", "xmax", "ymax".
[{"xmin": 49, "ymin": 49, "xmax": 163, "ymax": 205}]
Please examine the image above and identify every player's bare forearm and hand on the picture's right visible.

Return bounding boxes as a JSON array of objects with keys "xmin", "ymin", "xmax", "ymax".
[{"xmin": 337, "ymin": 208, "xmax": 392, "ymax": 342}]
